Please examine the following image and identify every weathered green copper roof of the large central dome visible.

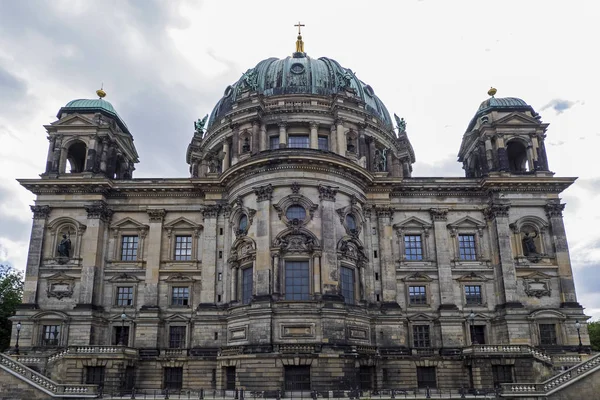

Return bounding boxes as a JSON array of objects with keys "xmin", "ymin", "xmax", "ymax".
[{"xmin": 209, "ymin": 53, "xmax": 392, "ymax": 128}]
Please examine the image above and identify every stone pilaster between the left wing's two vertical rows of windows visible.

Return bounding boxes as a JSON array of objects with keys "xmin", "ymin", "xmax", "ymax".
[{"xmin": 144, "ymin": 209, "xmax": 167, "ymax": 308}]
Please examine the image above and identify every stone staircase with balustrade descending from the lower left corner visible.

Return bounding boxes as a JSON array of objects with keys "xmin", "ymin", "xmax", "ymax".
[{"xmin": 0, "ymin": 353, "xmax": 98, "ymax": 399}]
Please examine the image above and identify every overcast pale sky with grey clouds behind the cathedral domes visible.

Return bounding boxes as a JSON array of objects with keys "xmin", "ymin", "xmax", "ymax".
[{"xmin": 0, "ymin": 0, "xmax": 600, "ymax": 319}]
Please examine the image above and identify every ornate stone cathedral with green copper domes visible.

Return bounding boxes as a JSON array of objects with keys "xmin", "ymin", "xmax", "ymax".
[{"xmin": 0, "ymin": 29, "xmax": 590, "ymax": 397}]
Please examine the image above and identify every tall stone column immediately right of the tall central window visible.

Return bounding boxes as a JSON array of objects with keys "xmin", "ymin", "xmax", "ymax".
[{"xmin": 319, "ymin": 185, "xmax": 339, "ymax": 295}]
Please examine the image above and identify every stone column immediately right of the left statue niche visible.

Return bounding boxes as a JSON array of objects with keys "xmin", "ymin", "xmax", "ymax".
[{"xmin": 77, "ymin": 202, "xmax": 113, "ymax": 307}]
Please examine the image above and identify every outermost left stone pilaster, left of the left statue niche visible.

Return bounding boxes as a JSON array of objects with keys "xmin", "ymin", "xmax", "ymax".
[{"xmin": 23, "ymin": 206, "xmax": 51, "ymax": 304}]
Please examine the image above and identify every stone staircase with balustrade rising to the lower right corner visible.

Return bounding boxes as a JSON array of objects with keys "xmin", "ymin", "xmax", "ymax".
[{"xmin": 502, "ymin": 353, "xmax": 600, "ymax": 399}]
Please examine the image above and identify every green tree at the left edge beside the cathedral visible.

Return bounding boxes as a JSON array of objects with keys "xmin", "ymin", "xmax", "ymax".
[{"xmin": 0, "ymin": 264, "xmax": 23, "ymax": 352}]
